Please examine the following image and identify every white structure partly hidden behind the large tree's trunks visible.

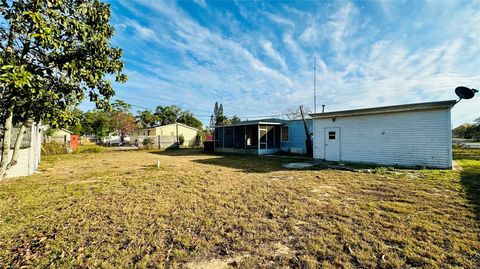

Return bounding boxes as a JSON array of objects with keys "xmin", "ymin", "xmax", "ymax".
[{"xmin": 0, "ymin": 123, "xmax": 42, "ymax": 178}]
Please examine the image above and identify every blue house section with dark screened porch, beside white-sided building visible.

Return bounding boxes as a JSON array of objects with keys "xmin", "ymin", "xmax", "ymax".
[{"xmin": 214, "ymin": 119, "xmax": 312, "ymax": 155}]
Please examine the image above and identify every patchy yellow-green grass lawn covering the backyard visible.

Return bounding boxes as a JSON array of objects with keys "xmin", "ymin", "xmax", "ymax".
[{"xmin": 0, "ymin": 149, "xmax": 480, "ymax": 268}]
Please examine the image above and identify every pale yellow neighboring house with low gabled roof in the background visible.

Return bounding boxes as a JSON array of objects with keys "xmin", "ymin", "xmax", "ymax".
[{"xmin": 130, "ymin": 123, "xmax": 200, "ymax": 148}]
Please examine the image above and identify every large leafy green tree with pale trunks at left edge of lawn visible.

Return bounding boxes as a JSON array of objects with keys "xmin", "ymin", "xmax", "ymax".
[{"xmin": 0, "ymin": 0, "xmax": 126, "ymax": 179}]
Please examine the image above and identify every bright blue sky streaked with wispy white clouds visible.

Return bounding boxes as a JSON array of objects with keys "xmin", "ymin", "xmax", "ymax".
[{"xmin": 82, "ymin": 0, "xmax": 480, "ymax": 126}]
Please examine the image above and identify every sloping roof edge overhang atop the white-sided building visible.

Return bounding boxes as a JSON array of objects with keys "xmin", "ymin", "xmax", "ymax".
[{"xmin": 310, "ymin": 100, "xmax": 457, "ymax": 119}]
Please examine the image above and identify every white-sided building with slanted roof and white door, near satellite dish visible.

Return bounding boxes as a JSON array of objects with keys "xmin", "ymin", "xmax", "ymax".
[{"xmin": 310, "ymin": 100, "xmax": 456, "ymax": 168}]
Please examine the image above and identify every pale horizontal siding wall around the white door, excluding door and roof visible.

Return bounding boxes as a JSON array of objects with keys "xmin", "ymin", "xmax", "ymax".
[{"xmin": 313, "ymin": 108, "xmax": 452, "ymax": 168}]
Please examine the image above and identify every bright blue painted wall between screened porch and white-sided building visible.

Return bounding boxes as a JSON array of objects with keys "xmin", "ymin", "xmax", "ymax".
[{"xmin": 280, "ymin": 119, "xmax": 313, "ymax": 154}]
